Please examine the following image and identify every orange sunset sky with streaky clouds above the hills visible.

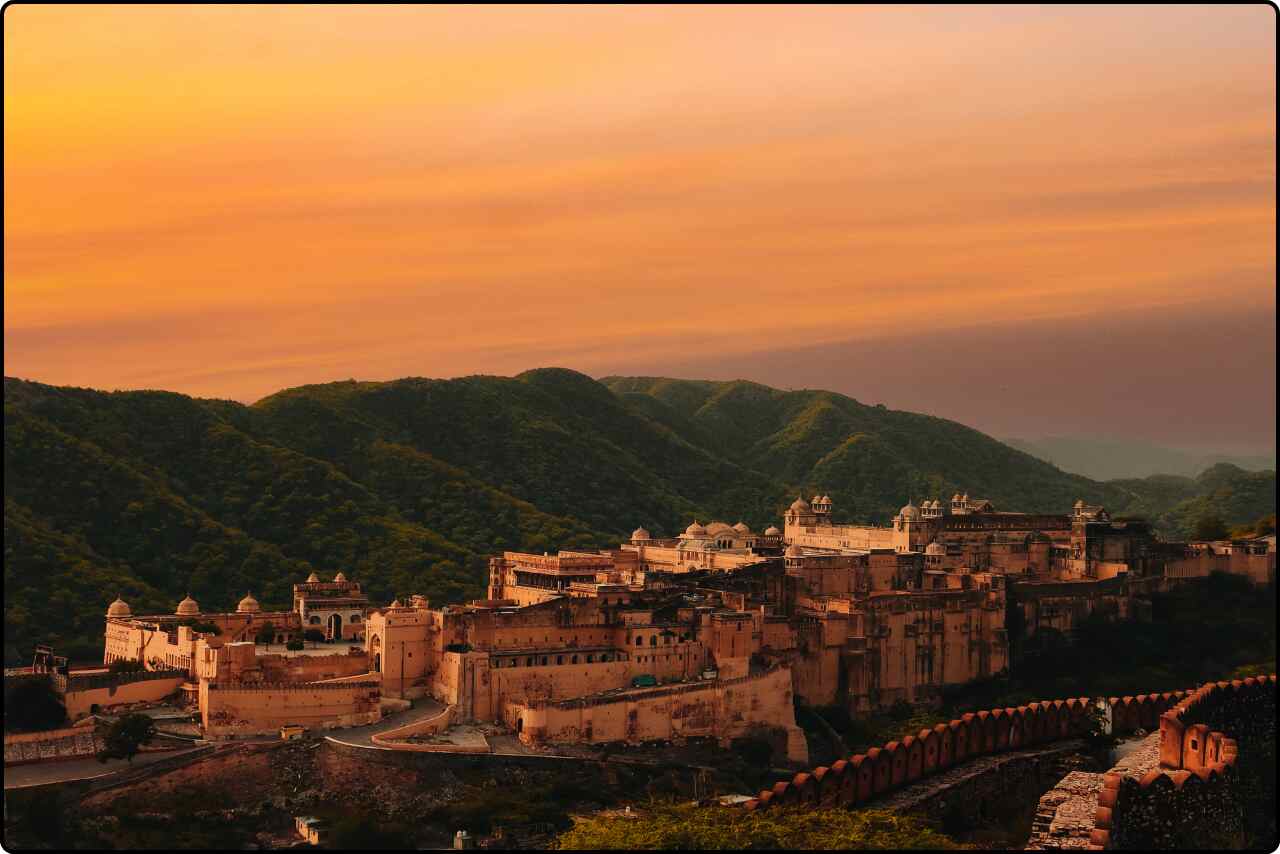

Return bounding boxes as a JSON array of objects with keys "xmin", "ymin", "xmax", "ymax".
[{"xmin": 4, "ymin": 5, "xmax": 1276, "ymax": 449}]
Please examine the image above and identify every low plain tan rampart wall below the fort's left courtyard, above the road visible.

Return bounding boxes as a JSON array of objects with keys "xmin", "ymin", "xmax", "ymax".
[{"xmin": 200, "ymin": 680, "xmax": 381, "ymax": 739}]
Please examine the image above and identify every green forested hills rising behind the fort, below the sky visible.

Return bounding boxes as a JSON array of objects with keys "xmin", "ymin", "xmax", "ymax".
[{"xmin": 5, "ymin": 369, "xmax": 1275, "ymax": 661}]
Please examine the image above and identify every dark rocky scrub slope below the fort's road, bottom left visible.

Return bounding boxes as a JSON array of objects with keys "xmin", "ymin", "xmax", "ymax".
[{"xmin": 5, "ymin": 739, "xmax": 711, "ymax": 849}]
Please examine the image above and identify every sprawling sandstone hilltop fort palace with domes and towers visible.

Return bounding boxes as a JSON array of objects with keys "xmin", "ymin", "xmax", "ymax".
[{"xmin": 77, "ymin": 494, "xmax": 1275, "ymax": 762}]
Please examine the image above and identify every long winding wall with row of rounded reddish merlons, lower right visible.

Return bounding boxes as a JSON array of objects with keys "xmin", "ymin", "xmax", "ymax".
[{"xmin": 742, "ymin": 676, "xmax": 1275, "ymax": 830}]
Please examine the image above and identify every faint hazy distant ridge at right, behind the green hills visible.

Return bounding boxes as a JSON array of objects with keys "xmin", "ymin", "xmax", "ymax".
[{"xmin": 1004, "ymin": 437, "xmax": 1276, "ymax": 480}]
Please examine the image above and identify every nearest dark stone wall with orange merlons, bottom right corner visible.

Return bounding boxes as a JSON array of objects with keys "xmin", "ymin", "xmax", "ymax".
[{"xmin": 1089, "ymin": 675, "xmax": 1276, "ymax": 849}]
